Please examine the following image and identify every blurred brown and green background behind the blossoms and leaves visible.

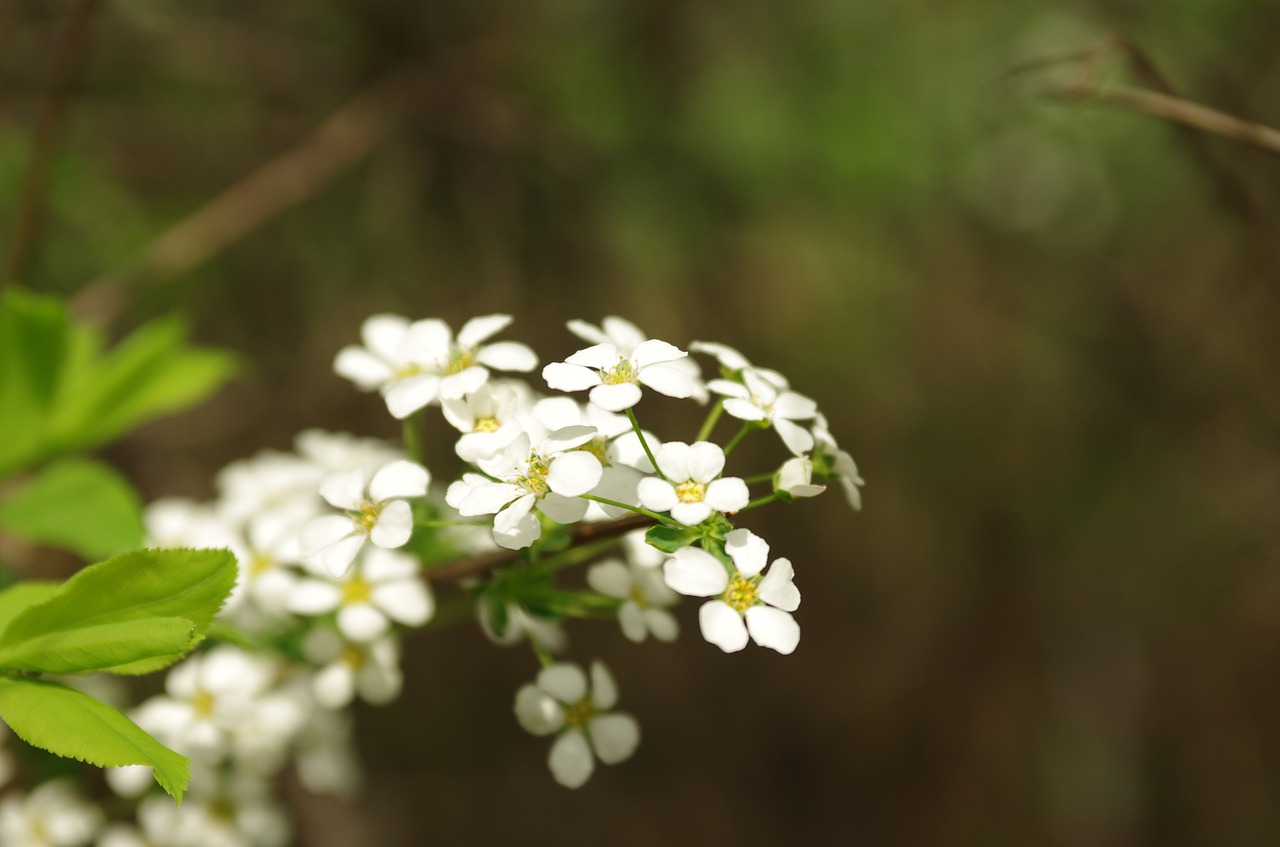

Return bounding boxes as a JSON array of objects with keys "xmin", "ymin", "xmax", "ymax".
[{"xmin": 0, "ymin": 0, "xmax": 1280, "ymax": 847}]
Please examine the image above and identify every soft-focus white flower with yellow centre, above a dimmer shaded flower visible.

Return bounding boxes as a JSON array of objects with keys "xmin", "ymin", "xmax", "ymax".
[{"xmin": 288, "ymin": 548, "xmax": 435, "ymax": 644}]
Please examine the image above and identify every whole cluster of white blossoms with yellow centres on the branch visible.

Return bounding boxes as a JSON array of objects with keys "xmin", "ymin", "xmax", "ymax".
[{"xmin": 0, "ymin": 315, "xmax": 863, "ymax": 847}]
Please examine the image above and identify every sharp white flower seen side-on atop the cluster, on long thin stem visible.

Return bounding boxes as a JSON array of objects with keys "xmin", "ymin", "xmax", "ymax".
[{"xmin": 543, "ymin": 339, "xmax": 694, "ymax": 412}]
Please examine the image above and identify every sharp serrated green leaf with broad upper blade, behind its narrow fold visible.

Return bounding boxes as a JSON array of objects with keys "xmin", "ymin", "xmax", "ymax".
[{"xmin": 0, "ymin": 549, "xmax": 236, "ymax": 673}]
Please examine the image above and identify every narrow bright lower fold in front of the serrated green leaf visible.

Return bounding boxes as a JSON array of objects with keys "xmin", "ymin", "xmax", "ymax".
[{"xmin": 0, "ymin": 618, "xmax": 196, "ymax": 673}]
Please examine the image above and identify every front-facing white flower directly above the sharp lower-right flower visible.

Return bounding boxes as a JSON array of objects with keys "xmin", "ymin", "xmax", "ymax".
[{"xmin": 637, "ymin": 441, "xmax": 751, "ymax": 526}]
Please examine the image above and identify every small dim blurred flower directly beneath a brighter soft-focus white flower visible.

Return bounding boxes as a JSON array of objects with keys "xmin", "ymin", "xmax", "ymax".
[{"xmin": 302, "ymin": 629, "xmax": 404, "ymax": 709}]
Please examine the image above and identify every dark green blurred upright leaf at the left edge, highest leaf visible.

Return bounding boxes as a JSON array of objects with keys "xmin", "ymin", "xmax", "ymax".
[{"xmin": 0, "ymin": 289, "xmax": 68, "ymax": 476}]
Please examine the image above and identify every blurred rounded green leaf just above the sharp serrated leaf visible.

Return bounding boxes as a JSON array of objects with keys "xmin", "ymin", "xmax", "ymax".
[{"xmin": 0, "ymin": 459, "xmax": 143, "ymax": 559}]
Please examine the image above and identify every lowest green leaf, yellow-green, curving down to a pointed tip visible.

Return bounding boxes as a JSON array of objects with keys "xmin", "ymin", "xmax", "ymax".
[{"xmin": 0, "ymin": 678, "xmax": 191, "ymax": 802}]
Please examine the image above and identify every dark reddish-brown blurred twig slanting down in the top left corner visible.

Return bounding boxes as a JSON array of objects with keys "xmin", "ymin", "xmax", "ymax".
[{"xmin": 0, "ymin": 0, "xmax": 97, "ymax": 287}]
